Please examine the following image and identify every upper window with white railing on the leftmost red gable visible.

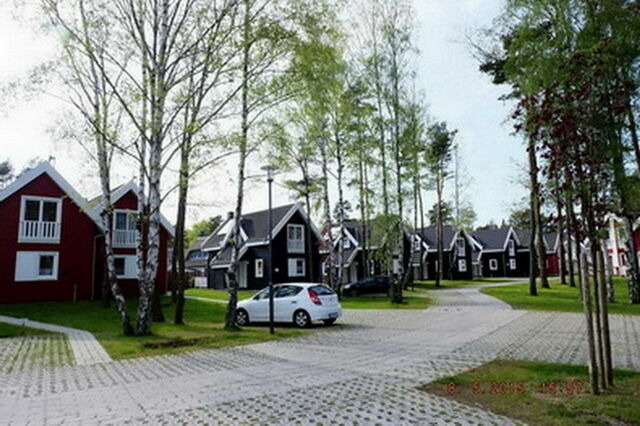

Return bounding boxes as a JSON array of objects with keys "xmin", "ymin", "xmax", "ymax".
[{"xmin": 18, "ymin": 196, "xmax": 62, "ymax": 243}]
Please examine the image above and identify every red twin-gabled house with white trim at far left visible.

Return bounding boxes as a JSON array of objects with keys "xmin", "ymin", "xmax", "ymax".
[{"xmin": 0, "ymin": 163, "xmax": 173, "ymax": 303}]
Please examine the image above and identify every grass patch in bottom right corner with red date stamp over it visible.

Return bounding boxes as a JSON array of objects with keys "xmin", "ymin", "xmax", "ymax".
[{"xmin": 421, "ymin": 360, "xmax": 640, "ymax": 425}]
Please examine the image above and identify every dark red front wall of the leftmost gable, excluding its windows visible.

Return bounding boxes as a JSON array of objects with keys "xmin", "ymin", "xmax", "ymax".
[{"xmin": 0, "ymin": 174, "xmax": 99, "ymax": 303}]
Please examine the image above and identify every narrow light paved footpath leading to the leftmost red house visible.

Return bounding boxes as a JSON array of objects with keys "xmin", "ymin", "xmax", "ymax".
[{"xmin": 0, "ymin": 315, "xmax": 111, "ymax": 365}]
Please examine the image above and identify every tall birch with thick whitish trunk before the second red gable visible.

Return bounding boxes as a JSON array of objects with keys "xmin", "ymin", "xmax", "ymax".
[{"xmin": 42, "ymin": 0, "xmax": 236, "ymax": 335}]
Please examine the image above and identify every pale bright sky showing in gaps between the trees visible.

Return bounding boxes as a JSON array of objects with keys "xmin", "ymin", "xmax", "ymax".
[{"xmin": 0, "ymin": 0, "xmax": 525, "ymax": 230}]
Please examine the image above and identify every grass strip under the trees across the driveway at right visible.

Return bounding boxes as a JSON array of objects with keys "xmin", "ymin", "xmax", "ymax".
[{"xmin": 482, "ymin": 277, "xmax": 640, "ymax": 315}]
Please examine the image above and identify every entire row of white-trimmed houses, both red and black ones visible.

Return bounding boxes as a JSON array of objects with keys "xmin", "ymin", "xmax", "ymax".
[{"xmin": 0, "ymin": 163, "xmax": 624, "ymax": 303}]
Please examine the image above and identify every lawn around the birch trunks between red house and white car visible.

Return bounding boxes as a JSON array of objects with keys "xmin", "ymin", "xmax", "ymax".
[{"xmin": 2, "ymin": 298, "xmax": 306, "ymax": 359}]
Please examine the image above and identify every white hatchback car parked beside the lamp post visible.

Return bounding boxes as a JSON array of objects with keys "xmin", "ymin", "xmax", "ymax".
[{"xmin": 236, "ymin": 283, "xmax": 342, "ymax": 328}]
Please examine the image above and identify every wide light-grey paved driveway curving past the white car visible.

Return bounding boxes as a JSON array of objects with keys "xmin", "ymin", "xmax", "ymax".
[{"xmin": 0, "ymin": 288, "xmax": 640, "ymax": 424}]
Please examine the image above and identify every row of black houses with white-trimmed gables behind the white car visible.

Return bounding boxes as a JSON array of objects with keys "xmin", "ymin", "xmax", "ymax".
[{"xmin": 186, "ymin": 204, "xmax": 559, "ymax": 289}]
